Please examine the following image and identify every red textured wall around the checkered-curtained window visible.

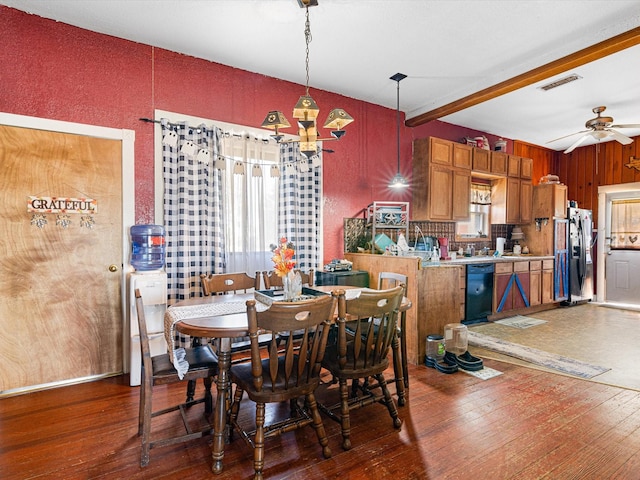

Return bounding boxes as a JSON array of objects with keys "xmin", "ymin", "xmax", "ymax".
[{"xmin": 0, "ymin": 6, "xmax": 510, "ymax": 260}]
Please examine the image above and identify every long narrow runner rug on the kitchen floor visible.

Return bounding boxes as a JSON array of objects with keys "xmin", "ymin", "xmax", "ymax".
[{"xmin": 468, "ymin": 330, "xmax": 610, "ymax": 378}]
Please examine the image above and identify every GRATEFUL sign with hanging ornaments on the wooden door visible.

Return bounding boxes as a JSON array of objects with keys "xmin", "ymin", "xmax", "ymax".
[{"xmin": 27, "ymin": 196, "xmax": 98, "ymax": 229}]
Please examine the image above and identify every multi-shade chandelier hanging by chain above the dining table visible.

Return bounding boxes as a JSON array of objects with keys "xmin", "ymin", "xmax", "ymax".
[{"xmin": 262, "ymin": 0, "xmax": 353, "ymax": 159}]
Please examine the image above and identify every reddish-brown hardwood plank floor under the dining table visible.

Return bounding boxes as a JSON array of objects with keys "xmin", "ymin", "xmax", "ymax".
[{"xmin": 0, "ymin": 360, "xmax": 640, "ymax": 480}]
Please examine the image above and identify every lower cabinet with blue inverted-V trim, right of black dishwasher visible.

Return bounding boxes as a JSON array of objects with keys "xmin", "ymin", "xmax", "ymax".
[{"xmin": 493, "ymin": 261, "xmax": 530, "ymax": 313}]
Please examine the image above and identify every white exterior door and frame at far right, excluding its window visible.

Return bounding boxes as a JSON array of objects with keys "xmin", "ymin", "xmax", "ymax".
[{"xmin": 596, "ymin": 182, "xmax": 640, "ymax": 308}]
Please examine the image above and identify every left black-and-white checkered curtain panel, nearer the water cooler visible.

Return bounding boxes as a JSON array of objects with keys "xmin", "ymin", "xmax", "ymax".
[{"xmin": 161, "ymin": 119, "xmax": 225, "ymax": 304}]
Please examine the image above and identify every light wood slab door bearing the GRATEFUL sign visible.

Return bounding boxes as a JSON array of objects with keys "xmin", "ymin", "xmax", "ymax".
[{"xmin": 0, "ymin": 126, "xmax": 123, "ymax": 393}]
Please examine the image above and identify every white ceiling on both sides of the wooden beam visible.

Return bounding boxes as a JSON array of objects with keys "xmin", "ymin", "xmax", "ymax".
[{"xmin": 0, "ymin": 0, "xmax": 640, "ymax": 150}]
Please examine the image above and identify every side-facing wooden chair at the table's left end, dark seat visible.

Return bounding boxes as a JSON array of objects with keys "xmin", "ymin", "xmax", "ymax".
[{"xmin": 135, "ymin": 289, "xmax": 218, "ymax": 467}]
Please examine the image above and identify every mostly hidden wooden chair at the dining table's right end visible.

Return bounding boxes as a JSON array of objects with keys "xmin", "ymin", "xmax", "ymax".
[{"xmin": 378, "ymin": 272, "xmax": 409, "ymax": 406}]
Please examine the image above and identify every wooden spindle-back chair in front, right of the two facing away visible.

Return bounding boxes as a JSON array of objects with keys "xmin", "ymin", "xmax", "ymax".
[{"xmin": 319, "ymin": 286, "xmax": 404, "ymax": 450}]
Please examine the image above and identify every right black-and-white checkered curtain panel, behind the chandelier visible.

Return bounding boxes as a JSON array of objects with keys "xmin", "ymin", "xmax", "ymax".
[{"xmin": 278, "ymin": 142, "xmax": 322, "ymax": 272}]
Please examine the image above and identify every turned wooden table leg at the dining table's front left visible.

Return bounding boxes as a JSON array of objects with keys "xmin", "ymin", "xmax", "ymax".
[{"xmin": 211, "ymin": 338, "xmax": 231, "ymax": 473}]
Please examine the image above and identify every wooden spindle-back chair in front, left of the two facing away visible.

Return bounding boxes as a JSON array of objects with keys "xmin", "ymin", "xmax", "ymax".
[{"xmin": 229, "ymin": 290, "xmax": 344, "ymax": 480}]
